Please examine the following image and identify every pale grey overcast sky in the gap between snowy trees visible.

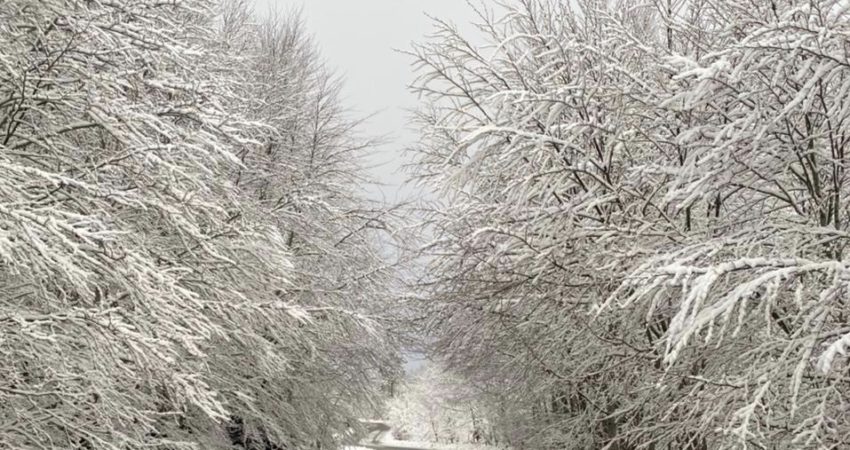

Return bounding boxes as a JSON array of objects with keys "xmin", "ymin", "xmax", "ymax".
[{"xmin": 248, "ymin": 0, "xmax": 474, "ymax": 201}]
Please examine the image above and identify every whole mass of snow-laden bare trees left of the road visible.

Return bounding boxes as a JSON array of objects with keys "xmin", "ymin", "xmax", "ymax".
[{"xmin": 0, "ymin": 0, "xmax": 398, "ymax": 449}]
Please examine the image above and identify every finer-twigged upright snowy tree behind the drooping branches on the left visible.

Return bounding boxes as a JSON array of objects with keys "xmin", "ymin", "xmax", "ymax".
[{"xmin": 209, "ymin": 2, "xmax": 400, "ymax": 446}]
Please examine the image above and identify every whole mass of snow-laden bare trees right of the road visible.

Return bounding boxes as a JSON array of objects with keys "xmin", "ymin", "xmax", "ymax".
[{"xmin": 413, "ymin": 0, "xmax": 850, "ymax": 450}]
